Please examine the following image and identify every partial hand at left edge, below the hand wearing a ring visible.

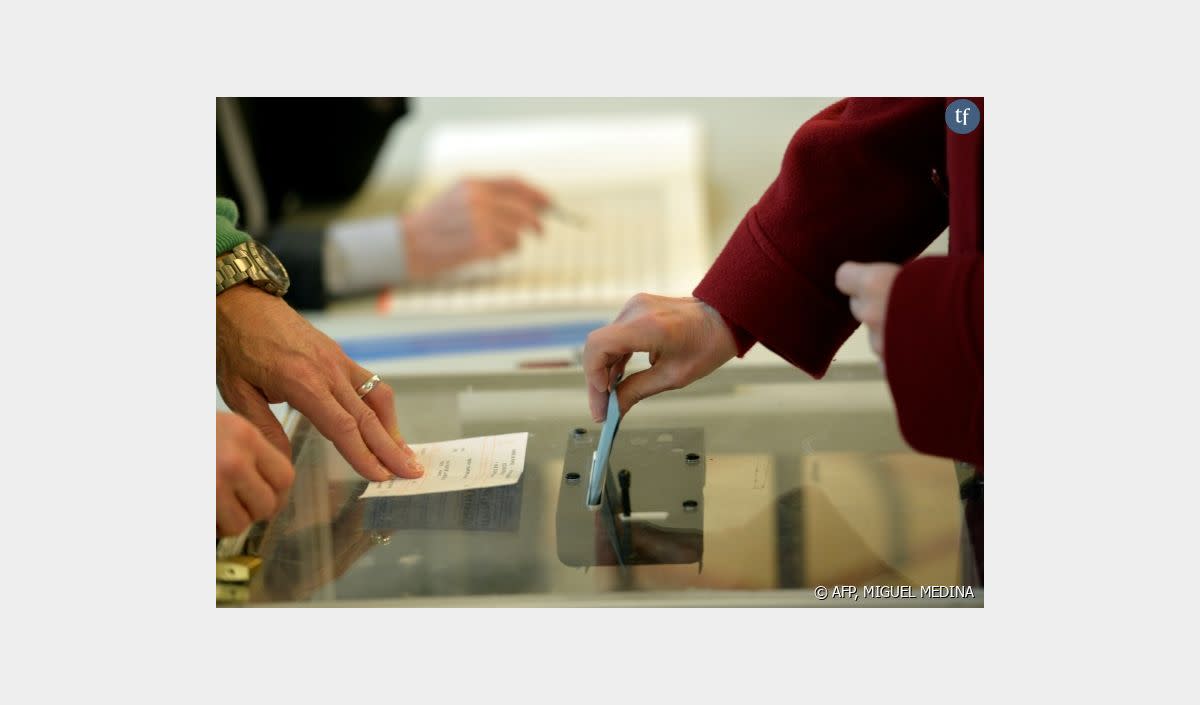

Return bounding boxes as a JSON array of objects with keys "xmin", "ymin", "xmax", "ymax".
[{"xmin": 217, "ymin": 411, "xmax": 295, "ymax": 536}]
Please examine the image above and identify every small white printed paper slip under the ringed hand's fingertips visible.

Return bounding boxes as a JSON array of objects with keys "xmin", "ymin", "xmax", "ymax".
[{"xmin": 359, "ymin": 433, "xmax": 529, "ymax": 499}]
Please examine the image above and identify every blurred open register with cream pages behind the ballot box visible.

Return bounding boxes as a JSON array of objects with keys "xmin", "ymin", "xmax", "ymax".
[{"xmin": 370, "ymin": 115, "xmax": 710, "ymax": 315}]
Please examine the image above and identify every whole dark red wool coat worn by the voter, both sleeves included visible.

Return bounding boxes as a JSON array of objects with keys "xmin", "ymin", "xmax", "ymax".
[{"xmin": 695, "ymin": 97, "xmax": 984, "ymax": 469}]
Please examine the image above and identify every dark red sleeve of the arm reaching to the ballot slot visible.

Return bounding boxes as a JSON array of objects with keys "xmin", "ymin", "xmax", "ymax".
[{"xmin": 694, "ymin": 98, "xmax": 947, "ymax": 378}]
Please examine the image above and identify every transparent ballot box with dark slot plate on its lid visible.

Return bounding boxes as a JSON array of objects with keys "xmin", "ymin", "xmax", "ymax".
[{"xmin": 218, "ymin": 363, "xmax": 983, "ymax": 607}]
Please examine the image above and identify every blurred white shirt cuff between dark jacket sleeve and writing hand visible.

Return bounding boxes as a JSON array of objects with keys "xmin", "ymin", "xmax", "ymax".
[{"xmin": 323, "ymin": 216, "xmax": 406, "ymax": 296}]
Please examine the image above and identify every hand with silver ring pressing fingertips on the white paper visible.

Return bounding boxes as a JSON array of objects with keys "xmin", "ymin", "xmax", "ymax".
[{"xmin": 217, "ymin": 284, "xmax": 424, "ymax": 481}]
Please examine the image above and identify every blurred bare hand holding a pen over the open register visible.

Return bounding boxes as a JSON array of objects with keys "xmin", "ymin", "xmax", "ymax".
[{"xmin": 402, "ymin": 179, "xmax": 550, "ymax": 281}]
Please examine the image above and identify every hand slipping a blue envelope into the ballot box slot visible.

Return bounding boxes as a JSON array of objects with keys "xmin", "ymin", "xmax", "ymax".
[{"xmin": 583, "ymin": 294, "xmax": 738, "ymax": 421}]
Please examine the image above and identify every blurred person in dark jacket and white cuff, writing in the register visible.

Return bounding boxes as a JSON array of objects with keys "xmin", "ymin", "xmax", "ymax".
[{"xmin": 216, "ymin": 97, "xmax": 550, "ymax": 309}]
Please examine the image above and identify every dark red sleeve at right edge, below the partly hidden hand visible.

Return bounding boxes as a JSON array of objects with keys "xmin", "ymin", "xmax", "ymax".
[{"xmin": 883, "ymin": 254, "xmax": 983, "ymax": 468}]
